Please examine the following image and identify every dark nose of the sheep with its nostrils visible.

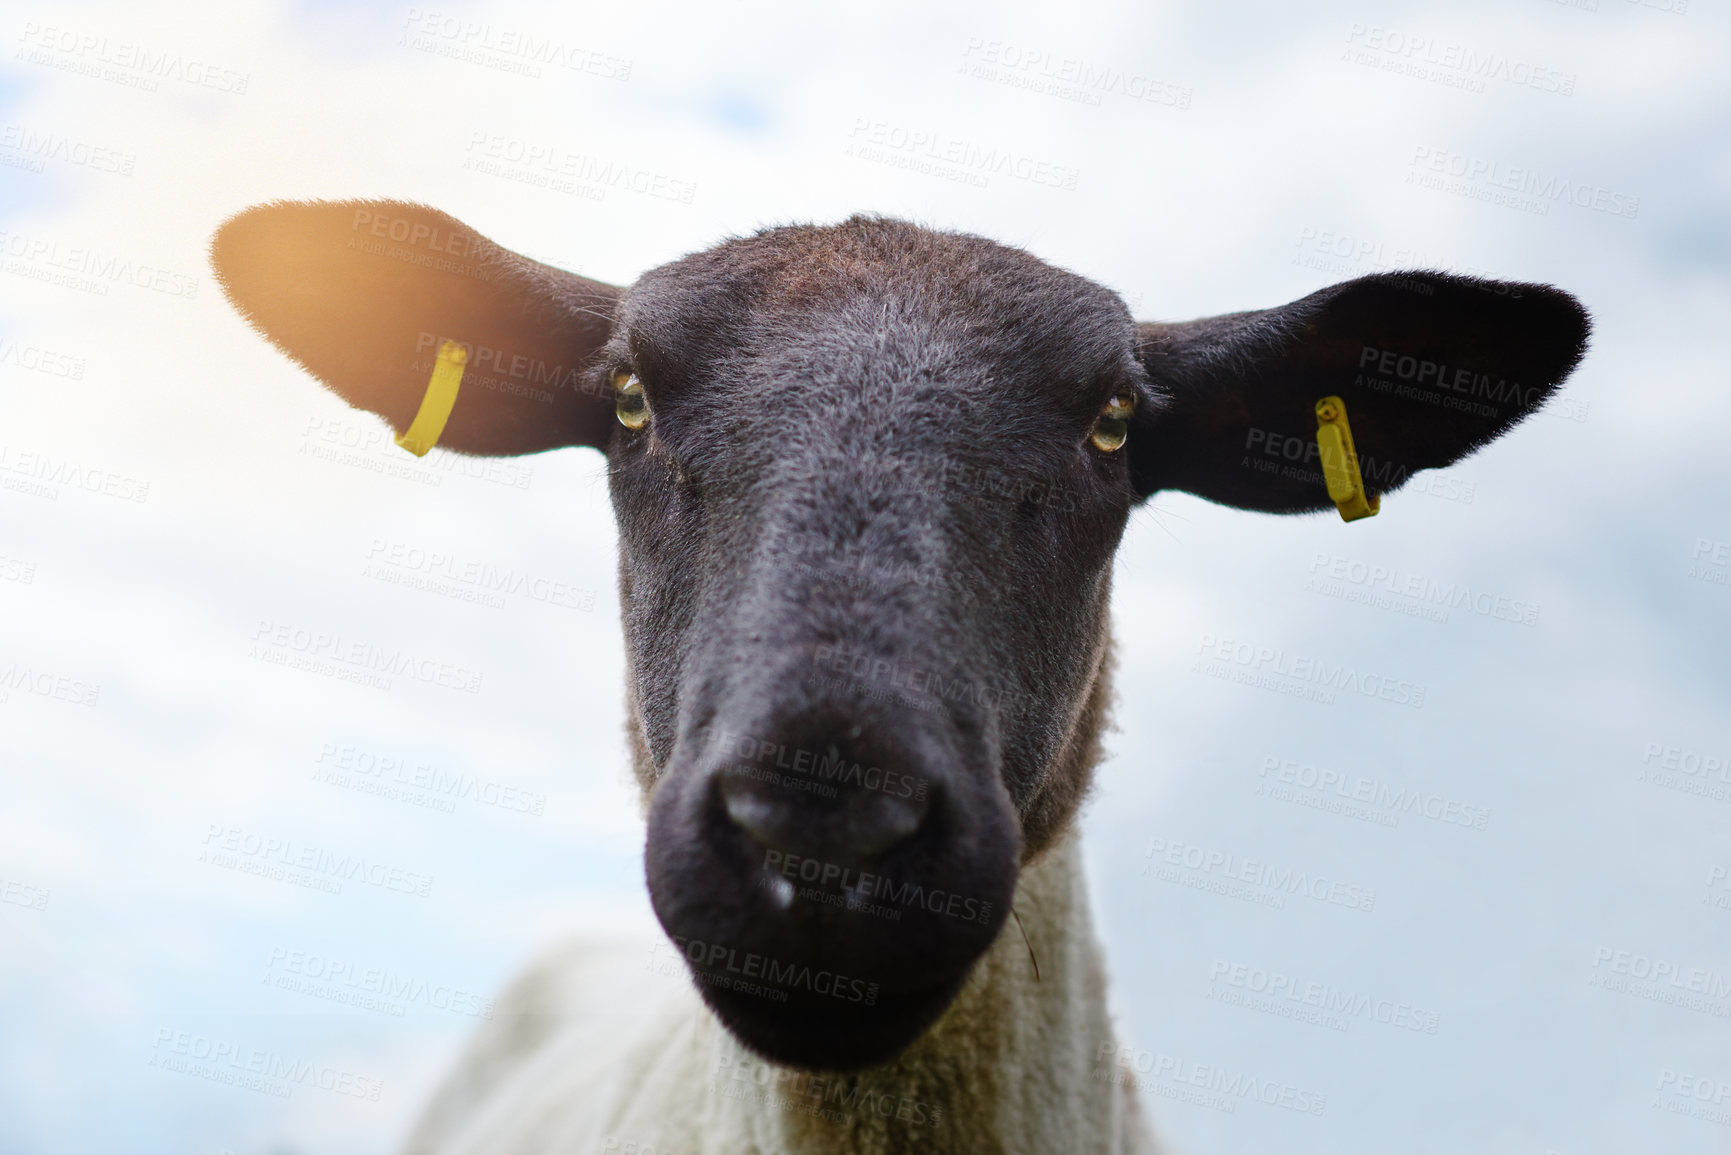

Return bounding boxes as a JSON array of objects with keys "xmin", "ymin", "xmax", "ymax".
[{"xmin": 718, "ymin": 771, "xmax": 930, "ymax": 861}]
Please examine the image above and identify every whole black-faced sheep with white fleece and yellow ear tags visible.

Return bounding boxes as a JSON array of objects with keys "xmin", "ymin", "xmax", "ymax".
[{"xmin": 211, "ymin": 201, "xmax": 1589, "ymax": 1155}]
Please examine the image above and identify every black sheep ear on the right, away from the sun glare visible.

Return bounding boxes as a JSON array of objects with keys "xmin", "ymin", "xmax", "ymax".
[{"xmin": 1130, "ymin": 272, "xmax": 1591, "ymax": 513}]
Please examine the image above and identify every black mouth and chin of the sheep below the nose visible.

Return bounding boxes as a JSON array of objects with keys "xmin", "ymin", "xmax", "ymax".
[{"xmin": 692, "ymin": 968, "xmax": 968, "ymax": 1072}]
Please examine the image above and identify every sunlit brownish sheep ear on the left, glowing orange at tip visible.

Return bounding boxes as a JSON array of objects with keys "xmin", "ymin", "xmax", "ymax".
[{"xmin": 211, "ymin": 201, "xmax": 620, "ymax": 455}]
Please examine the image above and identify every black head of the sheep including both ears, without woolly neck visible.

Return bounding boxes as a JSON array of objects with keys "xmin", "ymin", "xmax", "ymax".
[{"xmin": 213, "ymin": 203, "xmax": 1587, "ymax": 1068}]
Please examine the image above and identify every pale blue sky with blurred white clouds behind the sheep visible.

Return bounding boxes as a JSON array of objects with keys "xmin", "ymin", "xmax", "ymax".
[{"xmin": 0, "ymin": 0, "xmax": 1731, "ymax": 1155}]
